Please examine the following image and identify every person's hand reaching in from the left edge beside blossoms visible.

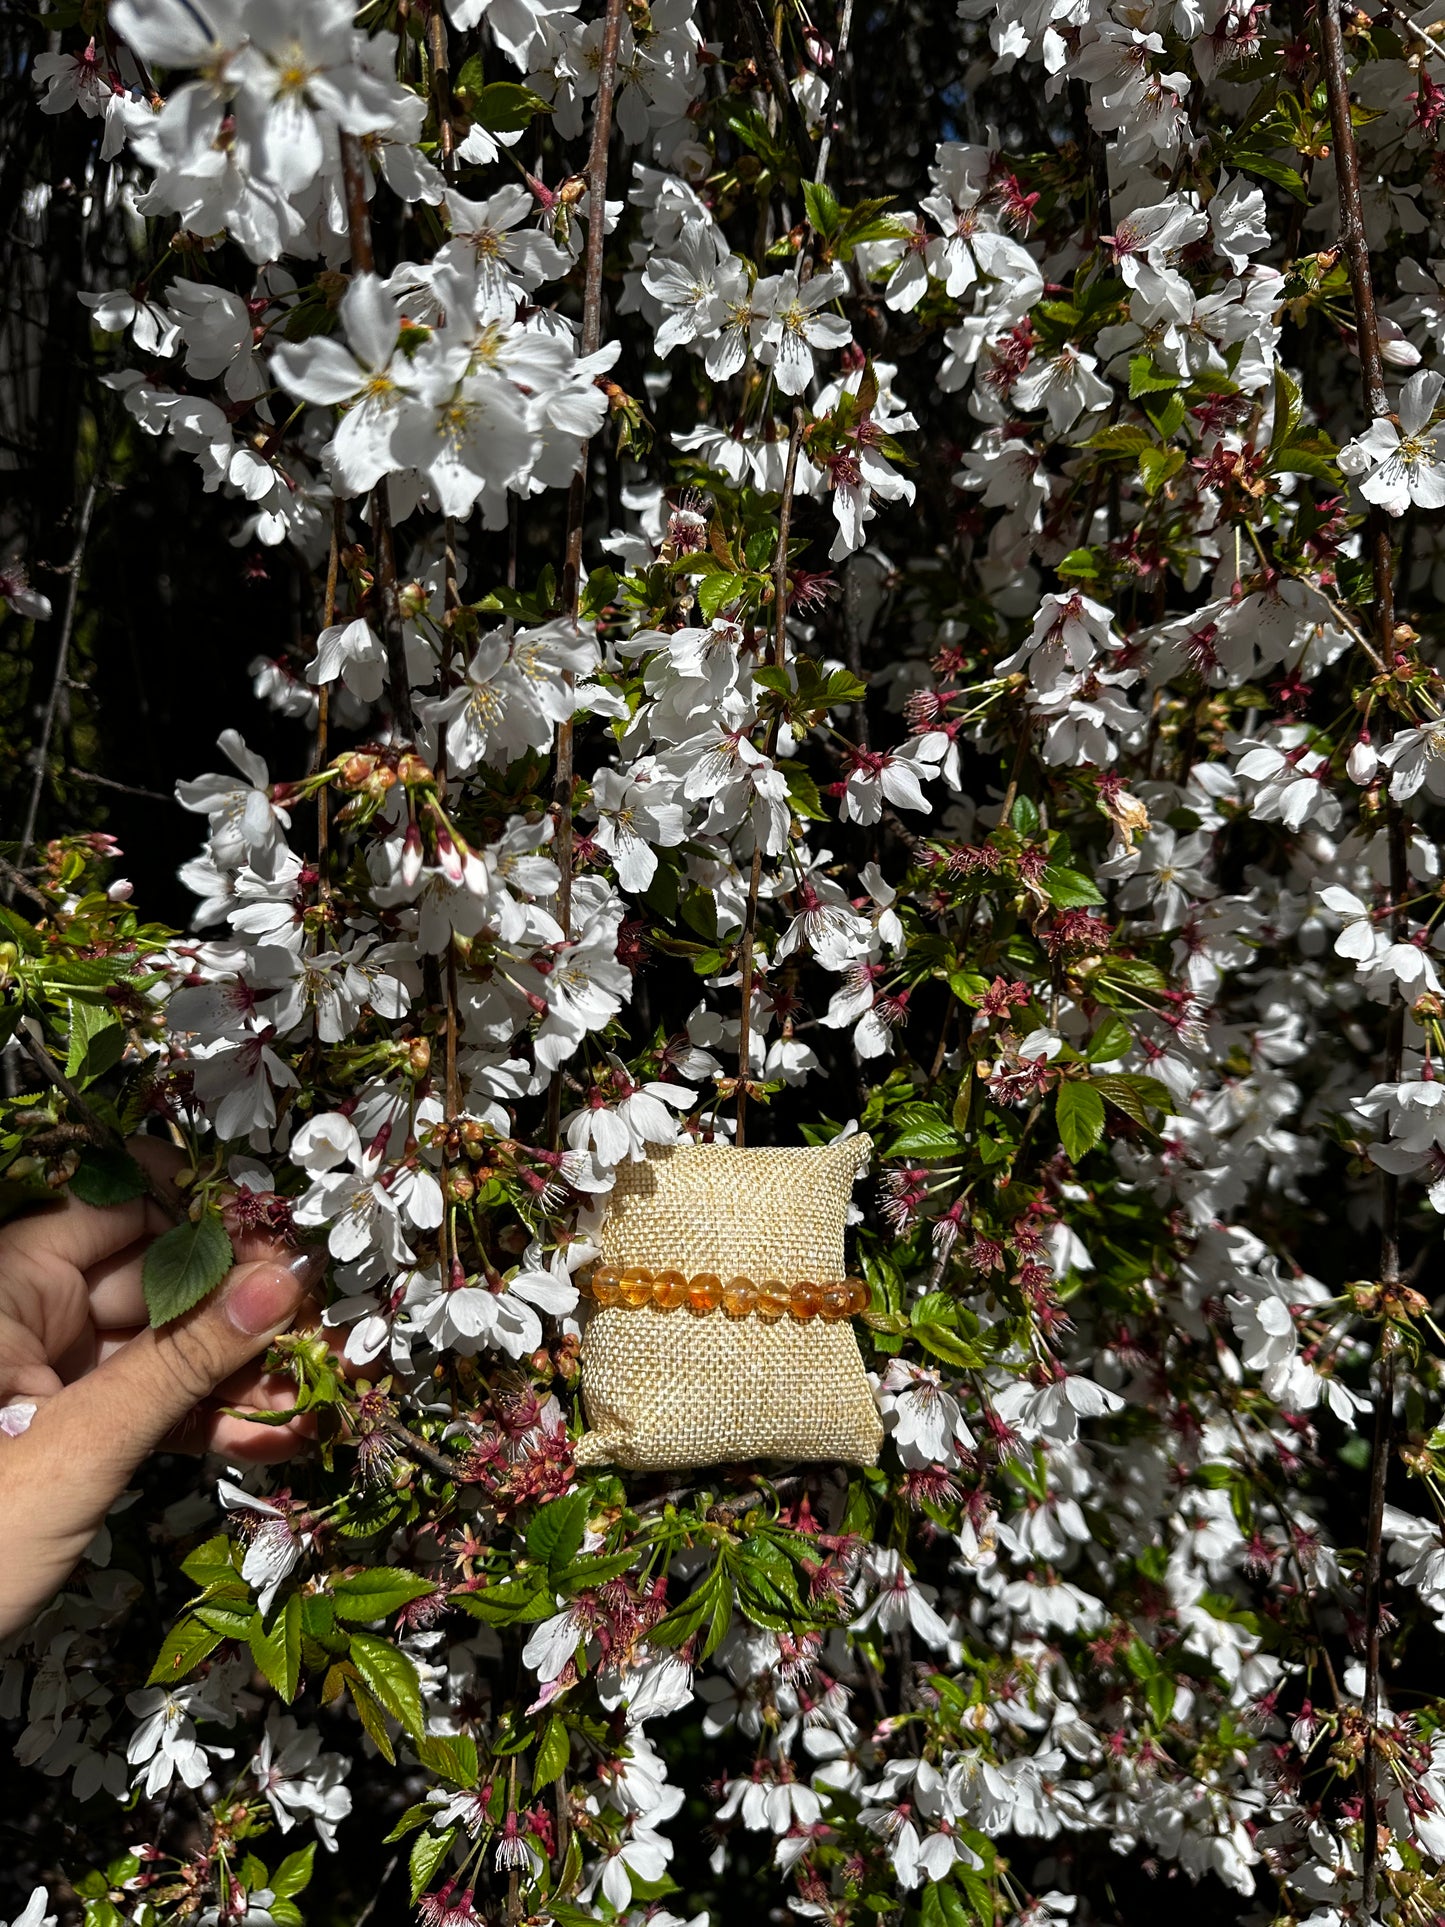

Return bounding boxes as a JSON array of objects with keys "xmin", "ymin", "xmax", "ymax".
[{"xmin": 0, "ymin": 1139, "xmax": 318, "ymax": 1636}]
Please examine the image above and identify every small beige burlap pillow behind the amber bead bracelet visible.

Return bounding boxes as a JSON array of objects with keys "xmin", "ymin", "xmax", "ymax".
[{"xmin": 576, "ymin": 1137, "xmax": 882, "ymax": 1472}]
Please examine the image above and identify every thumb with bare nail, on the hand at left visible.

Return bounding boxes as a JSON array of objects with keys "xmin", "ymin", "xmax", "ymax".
[{"xmin": 66, "ymin": 1253, "xmax": 324, "ymax": 1491}]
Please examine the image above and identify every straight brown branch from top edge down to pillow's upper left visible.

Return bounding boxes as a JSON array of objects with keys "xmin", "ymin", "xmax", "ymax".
[{"xmin": 547, "ymin": 0, "xmax": 624, "ymax": 1150}]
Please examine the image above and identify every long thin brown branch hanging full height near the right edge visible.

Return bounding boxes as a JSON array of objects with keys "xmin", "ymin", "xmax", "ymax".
[{"xmin": 1318, "ymin": 0, "xmax": 1410, "ymax": 1921}]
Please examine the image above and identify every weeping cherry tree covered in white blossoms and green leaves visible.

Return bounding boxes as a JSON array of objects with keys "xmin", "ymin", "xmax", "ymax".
[{"xmin": 0, "ymin": 0, "xmax": 1445, "ymax": 1927}]
